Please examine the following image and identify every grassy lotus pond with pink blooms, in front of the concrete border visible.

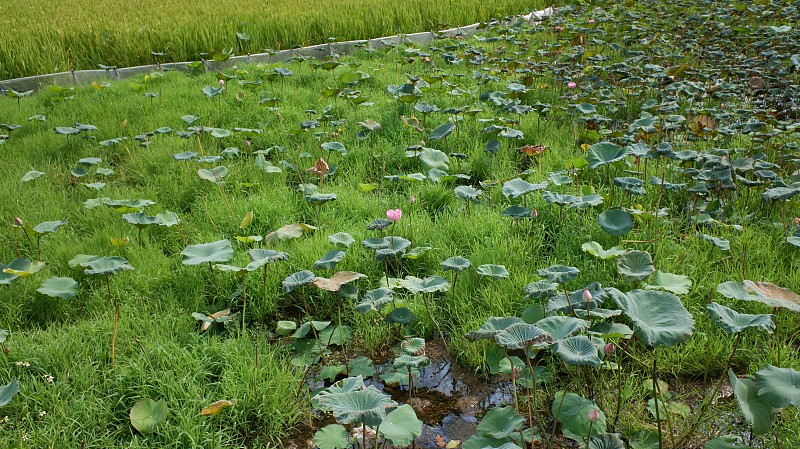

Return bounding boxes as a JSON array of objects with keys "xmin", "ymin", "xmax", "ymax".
[{"xmin": 0, "ymin": 0, "xmax": 800, "ymax": 449}]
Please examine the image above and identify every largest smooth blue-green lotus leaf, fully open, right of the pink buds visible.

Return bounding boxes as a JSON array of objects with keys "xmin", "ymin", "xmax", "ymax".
[{"xmin": 608, "ymin": 288, "xmax": 694, "ymax": 346}]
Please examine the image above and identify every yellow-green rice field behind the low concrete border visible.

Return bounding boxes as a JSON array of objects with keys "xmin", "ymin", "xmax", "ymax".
[{"xmin": 0, "ymin": 0, "xmax": 549, "ymax": 79}]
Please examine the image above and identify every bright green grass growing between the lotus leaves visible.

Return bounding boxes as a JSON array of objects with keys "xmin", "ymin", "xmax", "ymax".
[{"xmin": 0, "ymin": 1, "xmax": 800, "ymax": 448}]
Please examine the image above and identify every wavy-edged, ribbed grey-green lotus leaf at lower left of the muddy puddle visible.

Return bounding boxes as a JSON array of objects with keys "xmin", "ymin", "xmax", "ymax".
[{"xmin": 318, "ymin": 385, "xmax": 397, "ymax": 427}]
